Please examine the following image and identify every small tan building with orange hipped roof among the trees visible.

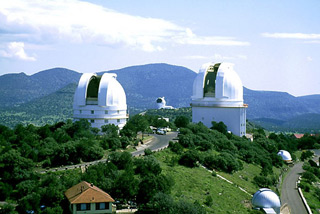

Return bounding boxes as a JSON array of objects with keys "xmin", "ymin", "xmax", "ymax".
[{"xmin": 64, "ymin": 181, "xmax": 116, "ymax": 214}]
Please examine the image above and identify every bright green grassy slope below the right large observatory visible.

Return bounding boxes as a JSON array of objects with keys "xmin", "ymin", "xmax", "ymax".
[{"xmin": 154, "ymin": 149, "xmax": 255, "ymax": 214}]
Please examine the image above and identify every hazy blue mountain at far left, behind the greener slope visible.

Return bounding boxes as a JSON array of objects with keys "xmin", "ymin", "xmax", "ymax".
[{"xmin": 0, "ymin": 68, "xmax": 81, "ymax": 108}]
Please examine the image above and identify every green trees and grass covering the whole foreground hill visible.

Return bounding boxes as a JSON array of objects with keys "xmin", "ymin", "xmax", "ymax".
[{"xmin": 0, "ymin": 111, "xmax": 320, "ymax": 213}]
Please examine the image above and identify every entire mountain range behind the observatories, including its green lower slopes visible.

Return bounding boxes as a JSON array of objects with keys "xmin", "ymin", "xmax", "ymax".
[{"xmin": 0, "ymin": 63, "xmax": 320, "ymax": 132}]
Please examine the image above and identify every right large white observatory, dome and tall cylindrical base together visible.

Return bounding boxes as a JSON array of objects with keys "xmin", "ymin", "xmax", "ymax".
[{"xmin": 191, "ymin": 63, "xmax": 248, "ymax": 136}]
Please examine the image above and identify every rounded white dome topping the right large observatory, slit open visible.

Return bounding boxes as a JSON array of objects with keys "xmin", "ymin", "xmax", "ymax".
[{"xmin": 191, "ymin": 63, "xmax": 243, "ymax": 106}]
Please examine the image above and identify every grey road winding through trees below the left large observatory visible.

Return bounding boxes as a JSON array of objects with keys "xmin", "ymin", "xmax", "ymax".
[{"xmin": 40, "ymin": 132, "xmax": 178, "ymax": 173}]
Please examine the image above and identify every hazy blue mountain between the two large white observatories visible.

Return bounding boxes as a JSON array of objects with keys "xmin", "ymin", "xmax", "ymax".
[{"xmin": 102, "ymin": 63, "xmax": 196, "ymax": 109}]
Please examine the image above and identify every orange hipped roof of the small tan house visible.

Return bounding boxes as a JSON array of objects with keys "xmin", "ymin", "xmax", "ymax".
[{"xmin": 64, "ymin": 181, "xmax": 114, "ymax": 204}]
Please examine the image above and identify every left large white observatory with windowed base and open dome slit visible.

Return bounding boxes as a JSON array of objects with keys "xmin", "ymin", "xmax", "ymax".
[{"xmin": 73, "ymin": 73, "xmax": 128, "ymax": 129}]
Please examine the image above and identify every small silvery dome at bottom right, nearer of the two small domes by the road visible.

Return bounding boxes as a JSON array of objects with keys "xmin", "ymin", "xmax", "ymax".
[{"xmin": 252, "ymin": 188, "xmax": 281, "ymax": 213}]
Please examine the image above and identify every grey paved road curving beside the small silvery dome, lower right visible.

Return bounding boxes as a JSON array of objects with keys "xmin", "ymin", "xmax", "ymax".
[{"xmin": 281, "ymin": 162, "xmax": 308, "ymax": 214}]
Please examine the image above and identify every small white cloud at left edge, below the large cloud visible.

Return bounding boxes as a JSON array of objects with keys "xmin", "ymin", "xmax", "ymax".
[{"xmin": 0, "ymin": 42, "xmax": 36, "ymax": 61}]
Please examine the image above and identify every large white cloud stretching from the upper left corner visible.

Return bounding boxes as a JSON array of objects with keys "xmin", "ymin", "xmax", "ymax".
[{"xmin": 0, "ymin": 0, "xmax": 249, "ymax": 52}]
